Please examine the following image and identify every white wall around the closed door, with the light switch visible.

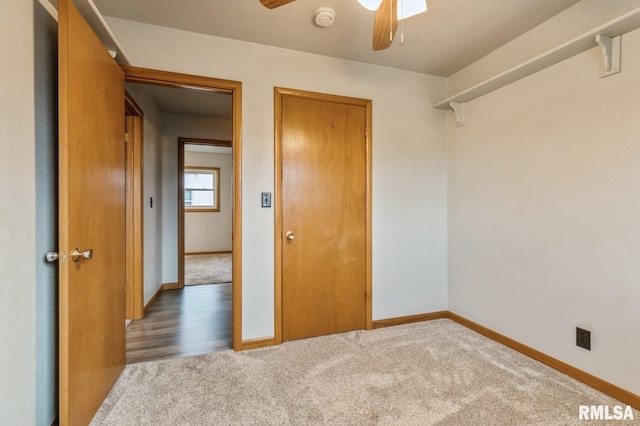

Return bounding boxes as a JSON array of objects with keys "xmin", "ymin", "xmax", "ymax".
[{"xmin": 108, "ymin": 18, "xmax": 447, "ymax": 339}]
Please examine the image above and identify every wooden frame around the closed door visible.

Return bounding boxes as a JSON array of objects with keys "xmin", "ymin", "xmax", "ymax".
[{"xmin": 274, "ymin": 87, "xmax": 373, "ymax": 345}]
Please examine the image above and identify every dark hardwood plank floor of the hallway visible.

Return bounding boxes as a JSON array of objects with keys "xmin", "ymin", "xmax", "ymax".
[{"xmin": 127, "ymin": 283, "xmax": 231, "ymax": 364}]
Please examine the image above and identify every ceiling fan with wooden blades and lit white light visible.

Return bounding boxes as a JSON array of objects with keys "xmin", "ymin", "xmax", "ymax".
[{"xmin": 260, "ymin": 0, "xmax": 427, "ymax": 50}]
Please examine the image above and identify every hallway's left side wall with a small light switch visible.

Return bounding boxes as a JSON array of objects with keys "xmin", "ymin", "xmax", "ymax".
[{"xmin": 126, "ymin": 83, "xmax": 163, "ymax": 304}]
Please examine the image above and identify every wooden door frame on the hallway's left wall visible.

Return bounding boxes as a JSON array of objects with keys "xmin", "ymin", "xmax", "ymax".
[{"xmin": 124, "ymin": 91, "xmax": 144, "ymax": 319}]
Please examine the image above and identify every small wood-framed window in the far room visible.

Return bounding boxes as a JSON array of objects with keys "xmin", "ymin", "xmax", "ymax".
[{"xmin": 184, "ymin": 167, "xmax": 220, "ymax": 212}]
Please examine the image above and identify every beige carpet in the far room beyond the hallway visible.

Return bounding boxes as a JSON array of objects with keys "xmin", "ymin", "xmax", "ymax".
[{"xmin": 184, "ymin": 253, "xmax": 231, "ymax": 285}]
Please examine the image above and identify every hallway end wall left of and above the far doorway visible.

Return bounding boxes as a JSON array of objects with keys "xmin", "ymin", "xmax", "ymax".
[{"xmin": 161, "ymin": 113, "xmax": 232, "ymax": 283}]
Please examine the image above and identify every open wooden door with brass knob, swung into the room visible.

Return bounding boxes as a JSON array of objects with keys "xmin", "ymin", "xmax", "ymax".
[{"xmin": 58, "ymin": 0, "xmax": 125, "ymax": 425}]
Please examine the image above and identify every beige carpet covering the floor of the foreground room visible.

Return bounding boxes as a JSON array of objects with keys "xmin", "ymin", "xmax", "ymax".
[{"xmin": 92, "ymin": 320, "xmax": 640, "ymax": 426}]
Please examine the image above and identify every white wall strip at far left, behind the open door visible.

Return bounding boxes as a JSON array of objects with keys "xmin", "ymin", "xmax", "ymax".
[{"xmin": 0, "ymin": 1, "xmax": 36, "ymax": 425}]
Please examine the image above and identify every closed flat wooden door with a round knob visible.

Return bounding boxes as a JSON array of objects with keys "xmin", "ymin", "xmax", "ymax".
[{"xmin": 280, "ymin": 91, "xmax": 368, "ymax": 340}]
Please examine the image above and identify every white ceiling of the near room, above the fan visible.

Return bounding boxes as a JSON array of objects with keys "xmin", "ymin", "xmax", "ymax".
[{"xmin": 91, "ymin": 0, "xmax": 579, "ymax": 77}]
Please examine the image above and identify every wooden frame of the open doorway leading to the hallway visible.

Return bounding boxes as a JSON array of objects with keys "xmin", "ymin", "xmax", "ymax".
[{"xmin": 122, "ymin": 65, "xmax": 242, "ymax": 350}]
